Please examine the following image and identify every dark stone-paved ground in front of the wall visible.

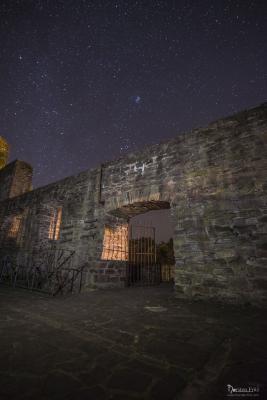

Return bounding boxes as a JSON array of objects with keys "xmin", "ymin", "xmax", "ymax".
[{"xmin": 0, "ymin": 286, "xmax": 267, "ymax": 400}]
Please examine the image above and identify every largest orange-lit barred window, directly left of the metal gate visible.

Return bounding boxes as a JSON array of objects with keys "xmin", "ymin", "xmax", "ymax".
[{"xmin": 101, "ymin": 224, "xmax": 128, "ymax": 261}]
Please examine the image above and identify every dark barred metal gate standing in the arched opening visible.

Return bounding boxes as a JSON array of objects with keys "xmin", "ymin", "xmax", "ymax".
[{"xmin": 127, "ymin": 225, "xmax": 161, "ymax": 286}]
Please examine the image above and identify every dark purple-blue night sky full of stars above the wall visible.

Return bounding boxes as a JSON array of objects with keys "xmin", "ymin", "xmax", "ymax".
[{"xmin": 0, "ymin": 0, "xmax": 267, "ymax": 187}]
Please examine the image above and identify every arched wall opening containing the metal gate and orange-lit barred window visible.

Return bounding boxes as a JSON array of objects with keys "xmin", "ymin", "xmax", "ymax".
[{"xmin": 105, "ymin": 200, "xmax": 175, "ymax": 286}]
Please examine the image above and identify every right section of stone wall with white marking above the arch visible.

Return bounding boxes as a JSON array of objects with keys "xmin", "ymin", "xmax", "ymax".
[{"xmin": 98, "ymin": 105, "xmax": 267, "ymax": 301}]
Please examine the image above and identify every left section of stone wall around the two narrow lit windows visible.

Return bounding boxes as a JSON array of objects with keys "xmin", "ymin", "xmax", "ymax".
[{"xmin": 0, "ymin": 170, "xmax": 101, "ymax": 262}]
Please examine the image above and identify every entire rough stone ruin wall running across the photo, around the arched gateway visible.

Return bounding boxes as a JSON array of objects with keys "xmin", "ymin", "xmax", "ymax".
[{"xmin": 0, "ymin": 103, "xmax": 267, "ymax": 304}]
